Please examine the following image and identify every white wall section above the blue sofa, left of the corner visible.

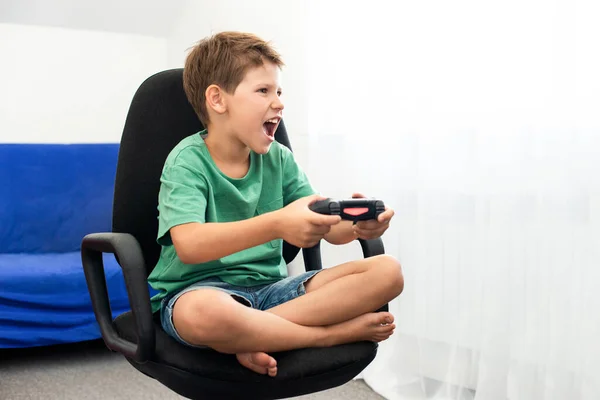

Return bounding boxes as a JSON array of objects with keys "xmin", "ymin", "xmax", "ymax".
[{"xmin": 0, "ymin": 24, "xmax": 167, "ymax": 143}]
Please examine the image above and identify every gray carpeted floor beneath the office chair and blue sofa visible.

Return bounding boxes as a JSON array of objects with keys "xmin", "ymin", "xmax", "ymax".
[{"xmin": 0, "ymin": 341, "xmax": 383, "ymax": 400}]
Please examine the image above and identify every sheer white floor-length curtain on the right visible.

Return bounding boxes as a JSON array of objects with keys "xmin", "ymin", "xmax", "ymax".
[{"xmin": 307, "ymin": 0, "xmax": 600, "ymax": 400}]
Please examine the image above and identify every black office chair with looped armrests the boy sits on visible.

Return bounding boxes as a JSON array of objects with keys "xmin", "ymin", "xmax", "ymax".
[{"xmin": 81, "ymin": 69, "xmax": 387, "ymax": 400}]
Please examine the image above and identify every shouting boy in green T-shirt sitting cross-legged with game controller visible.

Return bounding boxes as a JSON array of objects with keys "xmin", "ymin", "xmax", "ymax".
[{"xmin": 148, "ymin": 32, "xmax": 404, "ymax": 376}]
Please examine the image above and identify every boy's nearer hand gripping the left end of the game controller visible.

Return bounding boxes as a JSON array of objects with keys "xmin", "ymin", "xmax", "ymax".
[{"xmin": 276, "ymin": 195, "xmax": 341, "ymax": 248}]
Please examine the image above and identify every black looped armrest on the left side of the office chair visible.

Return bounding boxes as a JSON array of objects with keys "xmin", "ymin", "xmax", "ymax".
[{"xmin": 81, "ymin": 233, "xmax": 155, "ymax": 363}]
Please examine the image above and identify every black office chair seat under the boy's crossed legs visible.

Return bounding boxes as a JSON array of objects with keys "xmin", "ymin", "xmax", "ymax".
[{"xmin": 114, "ymin": 312, "xmax": 377, "ymax": 399}]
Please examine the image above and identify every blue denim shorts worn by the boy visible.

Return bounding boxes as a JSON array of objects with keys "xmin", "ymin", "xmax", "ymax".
[{"xmin": 160, "ymin": 270, "xmax": 320, "ymax": 348}]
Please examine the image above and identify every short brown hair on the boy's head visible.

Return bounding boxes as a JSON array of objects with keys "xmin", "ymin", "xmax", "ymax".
[{"xmin": 183, "ymin": 32, "xmax": 284, "ymax": 127}]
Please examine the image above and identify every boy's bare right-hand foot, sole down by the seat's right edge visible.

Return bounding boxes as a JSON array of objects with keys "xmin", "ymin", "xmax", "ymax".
[{"xmin": 327, "ymin": 312, "xmax": 396, "ymax": 346}]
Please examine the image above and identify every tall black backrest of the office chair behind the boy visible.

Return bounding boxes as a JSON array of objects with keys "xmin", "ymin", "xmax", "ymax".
[{"xmin": 113, "ymin": 69, "xmax": 299, "ymax": 274}]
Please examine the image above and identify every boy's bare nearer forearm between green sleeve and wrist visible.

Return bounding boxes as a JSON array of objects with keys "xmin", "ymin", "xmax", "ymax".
[{"xmin": 170, "ymin": 212, "xmax": 279, "ymax": 264}]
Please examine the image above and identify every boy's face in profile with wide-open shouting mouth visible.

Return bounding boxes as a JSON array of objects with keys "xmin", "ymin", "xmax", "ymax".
[{"xmin": 226, "ymin": 62, "xmax": 283, "ymax": 154}]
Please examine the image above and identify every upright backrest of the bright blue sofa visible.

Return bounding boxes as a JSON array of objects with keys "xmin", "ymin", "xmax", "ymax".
[{"xmin": 0, "ymin": 143, "xmax": 119, "ymax": 253}]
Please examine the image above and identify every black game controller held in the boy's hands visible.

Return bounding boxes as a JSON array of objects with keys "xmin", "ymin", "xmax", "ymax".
[{"xmin": 309, "ymin": 198, "xmax": 385, "ymax": 223}]
